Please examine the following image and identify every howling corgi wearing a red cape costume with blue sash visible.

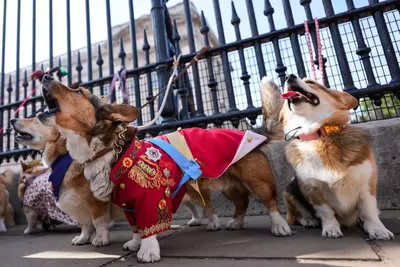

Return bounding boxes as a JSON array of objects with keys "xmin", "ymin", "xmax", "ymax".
[{"xmin": 38, "ymin": 75, "xmax": 291, "ymax": 262}]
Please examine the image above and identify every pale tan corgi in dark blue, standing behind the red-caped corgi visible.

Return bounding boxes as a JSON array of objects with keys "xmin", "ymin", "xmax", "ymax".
[{"xmin": 11, "ymin": 118, "xmax": 123, "ymax": 247}]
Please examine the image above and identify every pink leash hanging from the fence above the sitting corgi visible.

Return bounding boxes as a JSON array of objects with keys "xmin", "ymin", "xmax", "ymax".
[{"xmin": 304, "ymin": 18, "xmax": 325, "ymax": 84}]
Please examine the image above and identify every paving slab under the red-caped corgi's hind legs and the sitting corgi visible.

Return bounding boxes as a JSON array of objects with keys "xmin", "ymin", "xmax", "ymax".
[{"xmin": 161, "ymin": 216, "xmax": 379, "ymax": 260}]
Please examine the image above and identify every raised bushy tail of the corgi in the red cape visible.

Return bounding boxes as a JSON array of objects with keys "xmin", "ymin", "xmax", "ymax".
[{"xmin": 260, "ymin": 77, "xmax": 283, "ymax": 140}]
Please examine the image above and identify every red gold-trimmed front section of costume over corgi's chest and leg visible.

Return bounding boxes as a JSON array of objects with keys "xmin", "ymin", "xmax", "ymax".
[{"xmin": 110, "ymin": 140, "xmax": 185, "ymax": 238}]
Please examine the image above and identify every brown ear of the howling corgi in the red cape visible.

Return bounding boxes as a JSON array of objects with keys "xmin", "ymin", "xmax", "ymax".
[{"xmin": 98, "ymin": 104, "xmax": 139, "ymax": 123}]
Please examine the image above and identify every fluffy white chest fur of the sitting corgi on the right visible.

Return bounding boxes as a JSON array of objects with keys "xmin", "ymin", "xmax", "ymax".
[{"xmin": 295, "ymin": 142, "xmax": 374, "ymax": 214}]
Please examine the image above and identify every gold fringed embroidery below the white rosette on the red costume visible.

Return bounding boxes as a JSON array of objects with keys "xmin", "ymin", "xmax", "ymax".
[{"xmin": 128, "ymin": 155, "xmax": 175, "ymax": 189}]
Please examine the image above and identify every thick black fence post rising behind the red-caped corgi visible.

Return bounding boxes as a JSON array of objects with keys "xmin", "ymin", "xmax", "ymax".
[{"xmin": 151, "ymin": 0, "xmax": 176, "ymax": 129}]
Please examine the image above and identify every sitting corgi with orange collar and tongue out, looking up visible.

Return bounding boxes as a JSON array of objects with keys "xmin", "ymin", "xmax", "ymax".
[{"xmin": 262, "ymin": 74, "xmax": 393, "ymax": 240}]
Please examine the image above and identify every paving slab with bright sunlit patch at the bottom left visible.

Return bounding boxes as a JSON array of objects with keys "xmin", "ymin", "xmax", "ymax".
[{"xmin": 0, "ymin": 224, "xmax": 173, "ymax": 267}]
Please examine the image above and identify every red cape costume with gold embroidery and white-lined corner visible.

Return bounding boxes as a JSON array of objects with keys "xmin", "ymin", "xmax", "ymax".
[{"xmin": 110, "ymin": 128, "xmax": 266, "ymax": 238}]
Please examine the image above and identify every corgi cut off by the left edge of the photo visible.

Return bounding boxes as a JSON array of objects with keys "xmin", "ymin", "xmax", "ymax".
[{"xmin": 0, "ymin": 169, "xmax": 15, "ymax": 233}]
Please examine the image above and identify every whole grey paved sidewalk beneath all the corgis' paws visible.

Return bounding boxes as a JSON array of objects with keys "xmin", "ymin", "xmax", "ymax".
[{"xmin": 0, "ymin": 214, "xmax": 400, "ymax": 267}]
